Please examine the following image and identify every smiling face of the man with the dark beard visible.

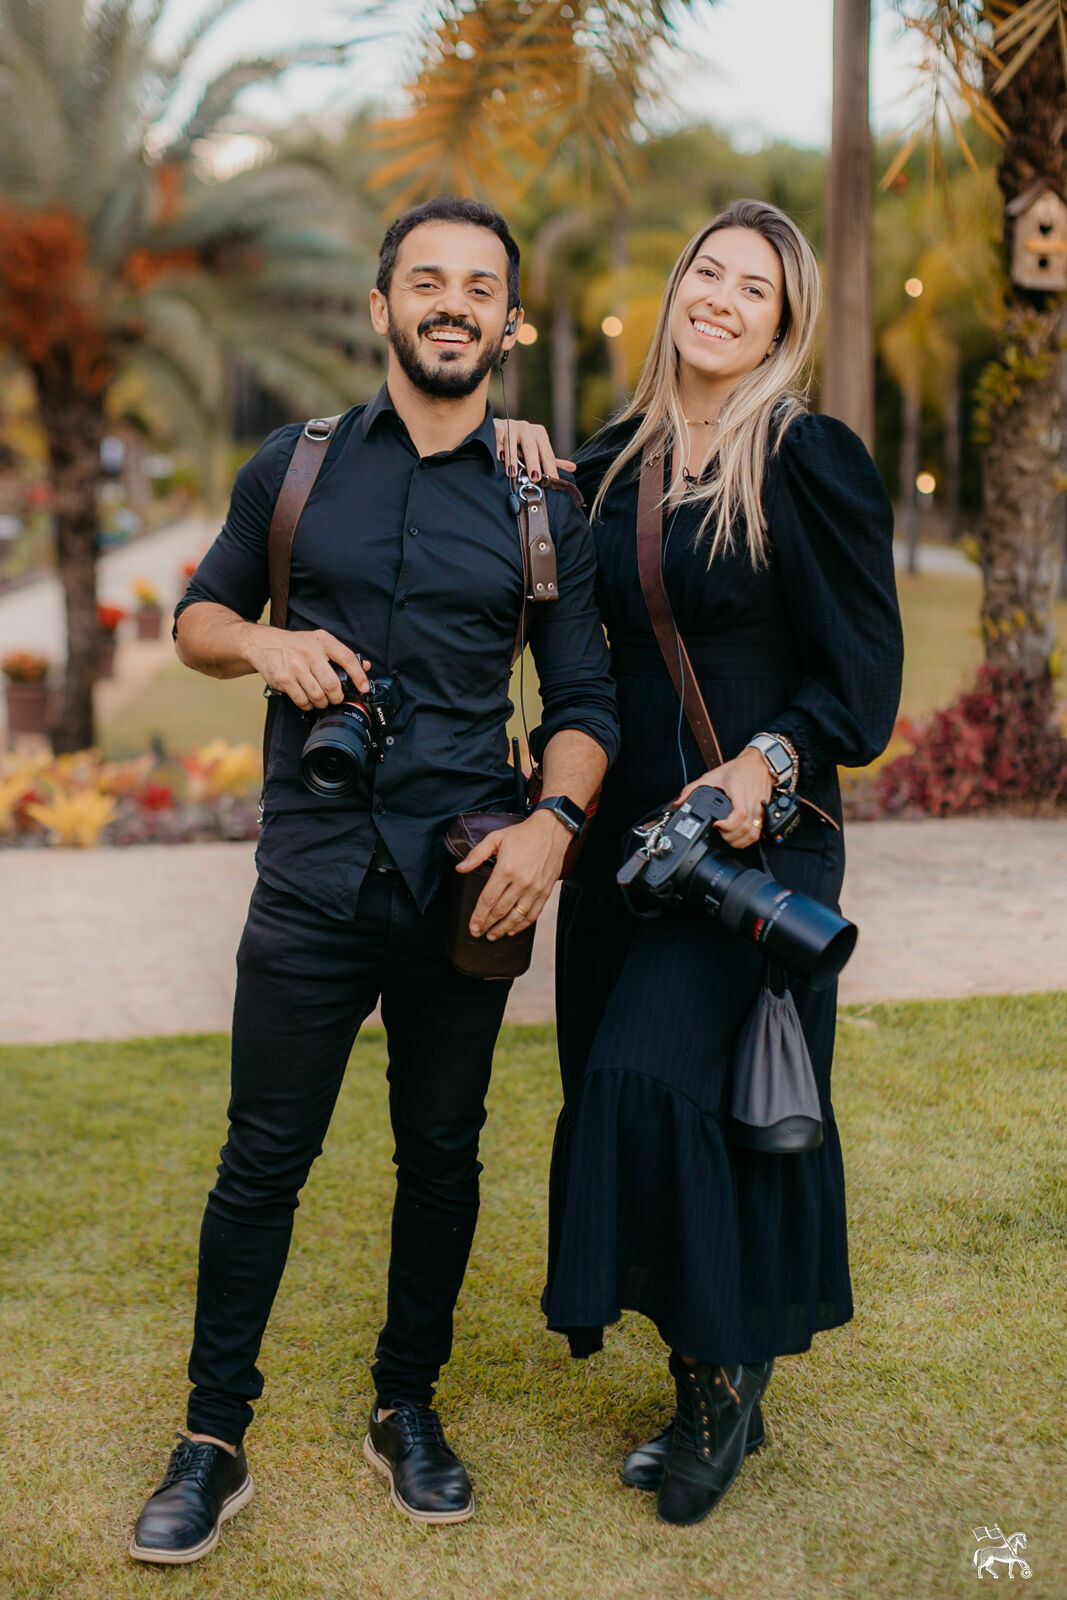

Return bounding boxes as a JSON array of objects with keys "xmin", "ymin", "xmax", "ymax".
[{"xmin": 371, "ymin": 222, "xmax": 522, "ymax": 398}]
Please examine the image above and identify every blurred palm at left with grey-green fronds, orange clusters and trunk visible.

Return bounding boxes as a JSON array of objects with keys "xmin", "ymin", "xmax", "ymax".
[{"xmin": 0, "ymin": 0, "xmax": 375, "ymax": 750}]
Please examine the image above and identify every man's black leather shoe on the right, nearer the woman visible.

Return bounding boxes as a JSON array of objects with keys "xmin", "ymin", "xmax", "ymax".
[{"xmin": 363, "ymin": 1402, "xmax": 474, "ymax": 1522}]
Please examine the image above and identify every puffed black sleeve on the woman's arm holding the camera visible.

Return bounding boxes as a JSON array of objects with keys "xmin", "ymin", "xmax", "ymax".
[{"xmin": 768, "ymin": 414, "xmax": 904, "ymax": 786}]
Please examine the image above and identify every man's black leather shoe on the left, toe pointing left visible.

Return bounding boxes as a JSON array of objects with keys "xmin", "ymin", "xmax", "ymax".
[{"xmin": 130, "ymin": 1434, "xmax": 253, "ymax": 1566}]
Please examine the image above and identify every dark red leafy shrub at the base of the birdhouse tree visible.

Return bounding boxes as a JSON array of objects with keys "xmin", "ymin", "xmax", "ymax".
[{"xmin": 875, "ymin": 667, "xmax": 1067, "ymax": 816}]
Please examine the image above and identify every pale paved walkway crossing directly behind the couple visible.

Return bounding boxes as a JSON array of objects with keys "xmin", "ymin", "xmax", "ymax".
[{"xmin": 0, "ymin": 819, "xmax": 1067, "ymax": 1043}]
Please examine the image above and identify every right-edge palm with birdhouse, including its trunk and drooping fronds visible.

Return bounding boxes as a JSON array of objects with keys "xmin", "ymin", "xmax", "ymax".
[{"xmin": 883, "ymin": 0, "xmax": 1067, "ymax": 680}]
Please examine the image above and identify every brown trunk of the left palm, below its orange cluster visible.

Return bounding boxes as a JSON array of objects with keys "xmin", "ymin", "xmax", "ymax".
[{"xmin": 38, "ymin": 374, "xmax": 106, "ymax": 755}]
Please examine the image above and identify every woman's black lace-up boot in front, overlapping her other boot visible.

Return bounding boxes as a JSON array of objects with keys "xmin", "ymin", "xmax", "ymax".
[{"xmin": 657, "ymin": 1354, "xmax": 774, "ymax": 1526}]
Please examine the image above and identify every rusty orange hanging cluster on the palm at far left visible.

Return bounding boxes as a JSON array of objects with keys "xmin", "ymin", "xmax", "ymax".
[{"xmin": 0, "ymin": 203, "xmax": 114, "ymax": 394}]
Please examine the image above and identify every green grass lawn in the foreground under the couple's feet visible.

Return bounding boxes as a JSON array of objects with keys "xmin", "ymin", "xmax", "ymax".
[{"xmin": 0, "ymin": 994, "xmax": 1067, "ymax": 1600}]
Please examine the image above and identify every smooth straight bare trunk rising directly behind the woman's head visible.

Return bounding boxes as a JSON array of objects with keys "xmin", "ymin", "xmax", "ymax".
[{"xmin": 822, "ymin": 0, "xmax": 875, "ymax": 450}]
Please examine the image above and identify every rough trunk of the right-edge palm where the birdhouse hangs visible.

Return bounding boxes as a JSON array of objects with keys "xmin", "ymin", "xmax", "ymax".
[{"xmin": 979, "ymin": 29, "xmax": 1067, "ymax": 678}]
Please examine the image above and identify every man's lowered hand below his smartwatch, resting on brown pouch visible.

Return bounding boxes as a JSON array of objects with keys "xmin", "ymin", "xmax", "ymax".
[{"xmin": 456, "ymin": 811, "xmax": 571, "ymax": 939}]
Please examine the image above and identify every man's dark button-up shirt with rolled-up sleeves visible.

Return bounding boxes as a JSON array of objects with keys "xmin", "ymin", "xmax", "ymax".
[{"xmin": 176, "ymin": 387, "xmax": 617, "ymax": 918}]
